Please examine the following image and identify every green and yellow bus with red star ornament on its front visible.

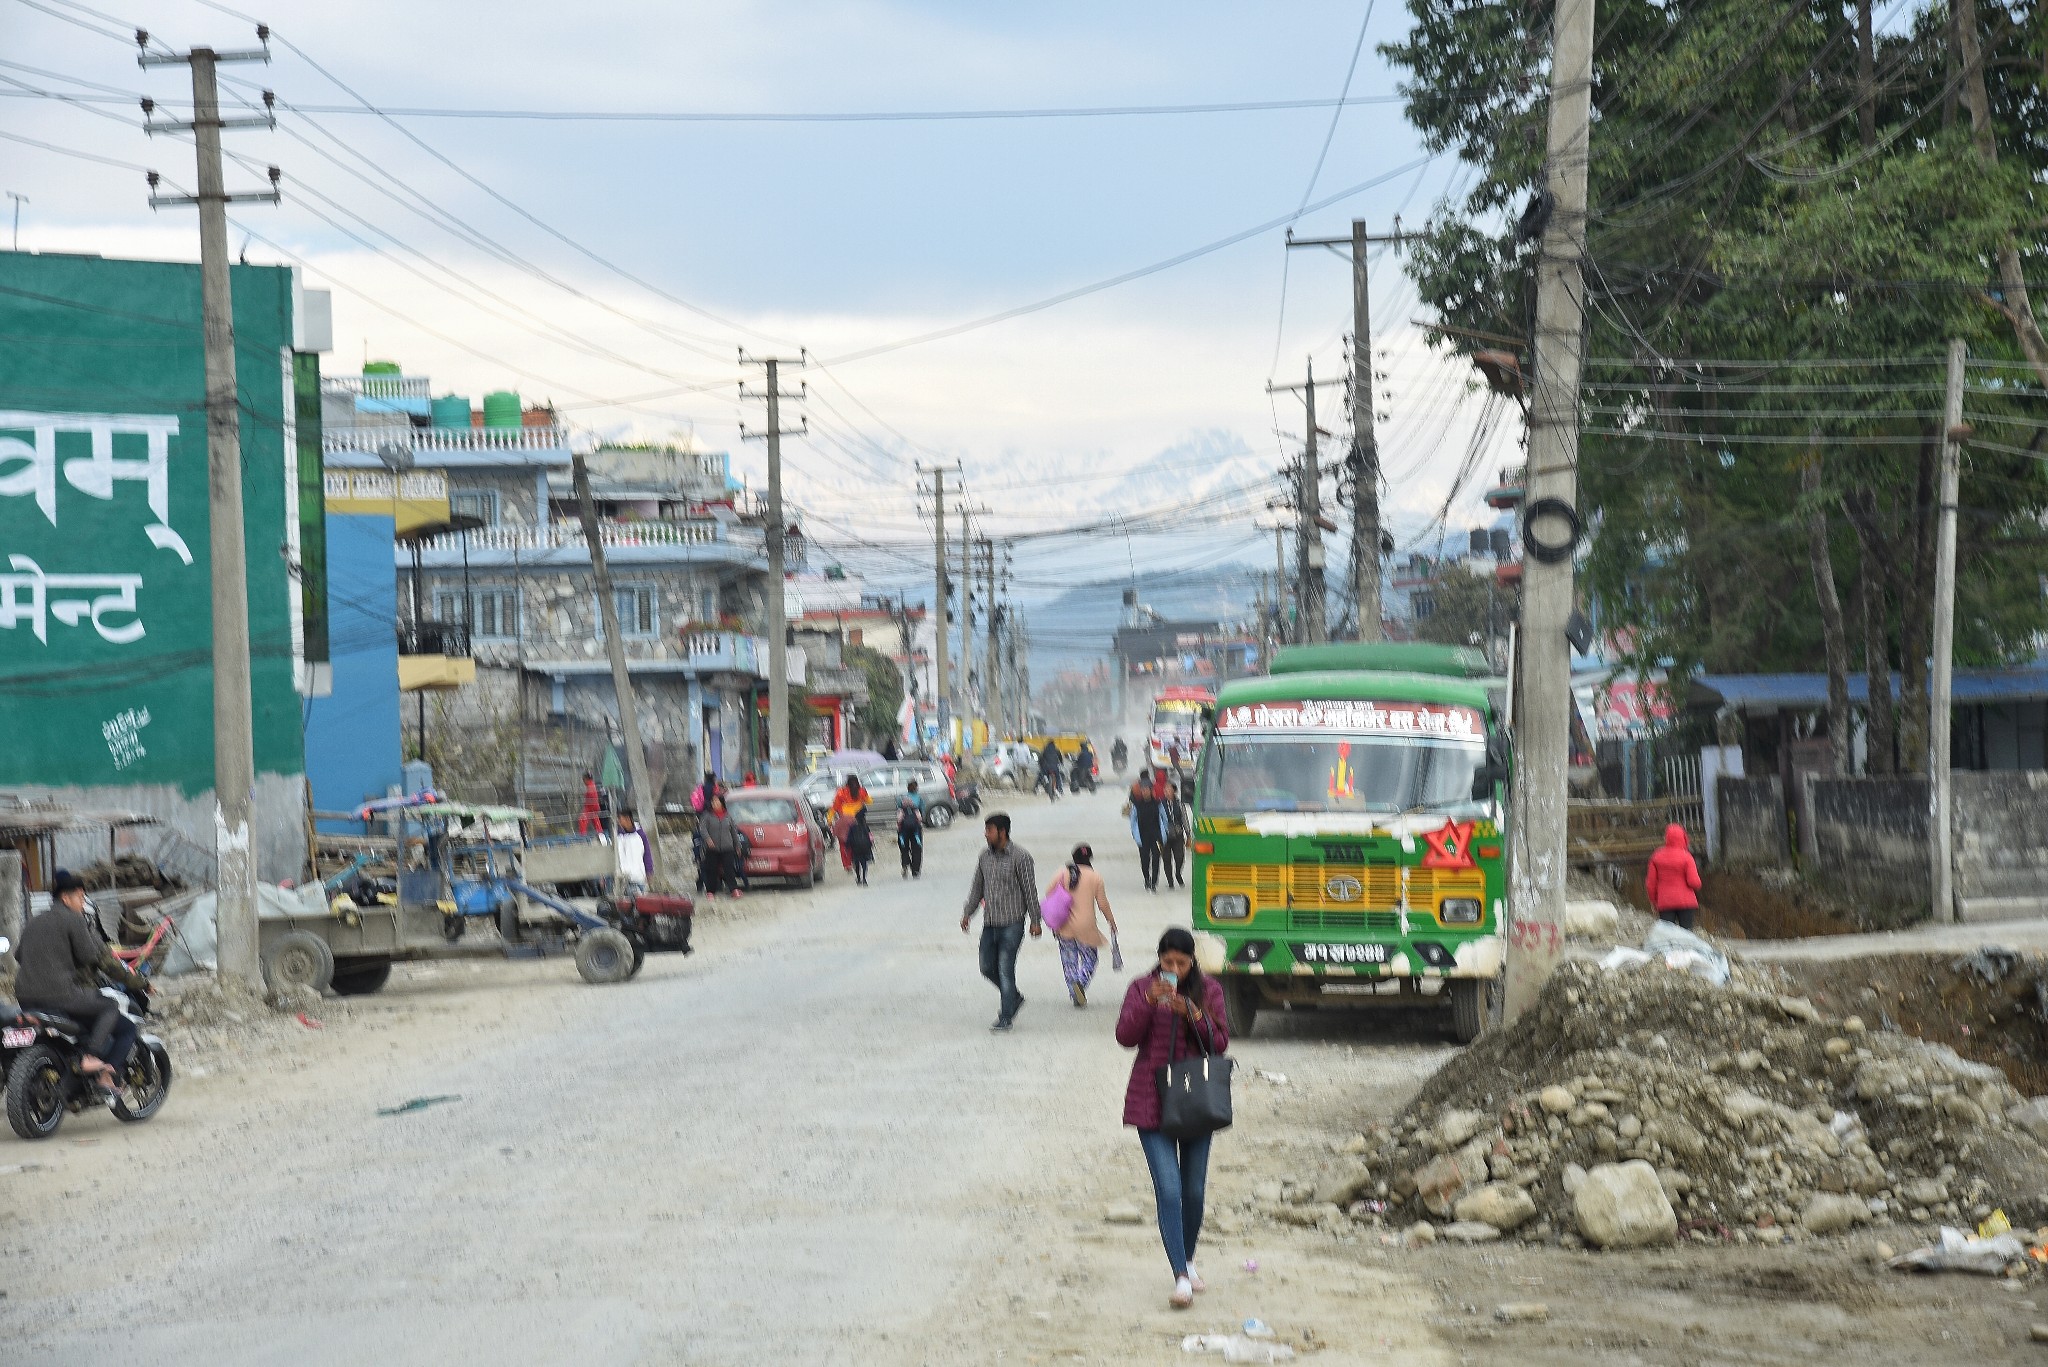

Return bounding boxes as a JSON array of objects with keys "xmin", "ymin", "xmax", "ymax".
[{"xmin": 1192, "ymin": 644, "xmax": 1507, "ymax": 1041}]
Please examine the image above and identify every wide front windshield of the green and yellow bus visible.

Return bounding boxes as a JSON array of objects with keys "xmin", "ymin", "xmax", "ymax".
[{"xmin": 1202, "ymin": 734, "xmax": 1487, "ymax": 816}]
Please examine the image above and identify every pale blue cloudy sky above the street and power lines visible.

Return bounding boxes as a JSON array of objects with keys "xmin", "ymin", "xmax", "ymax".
[{"xmin": 0, "ymin": 0, "xmax": 1520, "ymax": 614}]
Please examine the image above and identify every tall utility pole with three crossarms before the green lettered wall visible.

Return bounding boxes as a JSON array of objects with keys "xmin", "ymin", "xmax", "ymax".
[{"xmin": 135, "ymin": 25, "xmax": 291, "ymax": 992}]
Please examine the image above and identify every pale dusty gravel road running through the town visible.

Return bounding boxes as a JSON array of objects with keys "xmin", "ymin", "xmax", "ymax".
[{"xmin": 0, "ymin": 793, "xmax": 1474, "ymax": 1363}]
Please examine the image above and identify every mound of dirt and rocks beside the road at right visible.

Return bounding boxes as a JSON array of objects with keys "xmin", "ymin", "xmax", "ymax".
[{"xmin": 1372, "ymin": 963, "xmax": 2048, "ymax": 1240}]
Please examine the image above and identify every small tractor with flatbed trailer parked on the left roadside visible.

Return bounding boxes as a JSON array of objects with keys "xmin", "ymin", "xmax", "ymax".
[{"xmin": 258, "ymin": 801, "xmax": 679, "ymax": 996}]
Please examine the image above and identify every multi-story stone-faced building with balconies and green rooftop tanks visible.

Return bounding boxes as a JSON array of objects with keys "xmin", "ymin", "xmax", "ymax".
[{"xmin": 324, "ymin": 367, "xmax": 803, "ymax": 805}]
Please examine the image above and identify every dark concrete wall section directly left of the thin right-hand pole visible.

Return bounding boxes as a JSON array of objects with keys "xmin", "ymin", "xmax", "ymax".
[{"xmin": 1806, "ymin": 777, "xmax": 1929, "ymax": 910}]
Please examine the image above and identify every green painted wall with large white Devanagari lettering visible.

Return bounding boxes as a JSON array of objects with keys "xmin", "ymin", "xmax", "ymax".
[{"xmin": 0, "ymin": 252, "xmax": 307, "ymax": 795}]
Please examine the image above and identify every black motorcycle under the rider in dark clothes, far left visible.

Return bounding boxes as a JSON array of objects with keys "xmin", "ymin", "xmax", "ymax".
[{"xmin": 0, "ymin": 939, "xmax": 170, "ymax": 1140}]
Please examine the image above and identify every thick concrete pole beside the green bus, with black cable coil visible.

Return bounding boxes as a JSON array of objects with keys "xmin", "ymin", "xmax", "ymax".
[{"xmin": 1507, "ymin": 0, "xmax": 1593, "ymax": 1017}]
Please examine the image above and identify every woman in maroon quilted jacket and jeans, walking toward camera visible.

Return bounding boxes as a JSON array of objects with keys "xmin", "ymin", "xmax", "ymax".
[{"xmin": 1116, "ymin": 926, "xmax": 1231, "ymax": 1310}]
